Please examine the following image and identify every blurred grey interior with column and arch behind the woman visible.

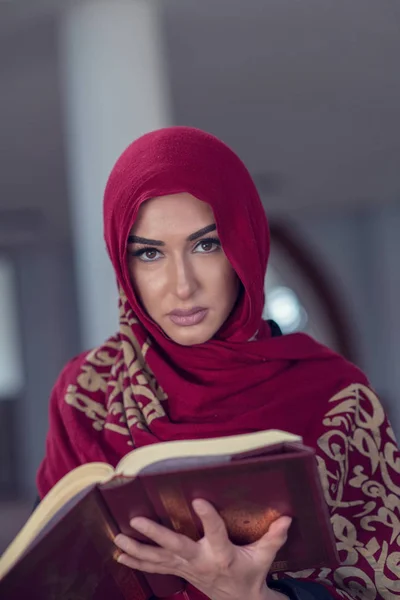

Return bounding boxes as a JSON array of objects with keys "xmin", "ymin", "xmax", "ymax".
[{"xmin": 0, "ymin": 0, "xmax": 400, "ymax": 551}]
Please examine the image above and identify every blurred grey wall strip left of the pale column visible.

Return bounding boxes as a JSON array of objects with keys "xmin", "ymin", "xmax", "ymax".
[{"xmin": 0, "ymin": 15, "xmax": 80, "ymax": 500}]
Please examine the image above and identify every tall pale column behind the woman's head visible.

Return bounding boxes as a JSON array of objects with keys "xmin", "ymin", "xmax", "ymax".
[{"xmin": 60, "ymin": 0, "xmax": 170, "ymax": 348}]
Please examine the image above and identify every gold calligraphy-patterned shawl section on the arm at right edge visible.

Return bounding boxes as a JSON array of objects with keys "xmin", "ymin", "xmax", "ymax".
[{"xmin": 286, "ymin": 384, "xmax": 400, "ymax": 600}]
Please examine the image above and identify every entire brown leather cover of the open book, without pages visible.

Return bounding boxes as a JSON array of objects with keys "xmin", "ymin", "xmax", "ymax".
[{"xmin": 0, "ymin": 444, "xmax": 338, "ymax": 600}]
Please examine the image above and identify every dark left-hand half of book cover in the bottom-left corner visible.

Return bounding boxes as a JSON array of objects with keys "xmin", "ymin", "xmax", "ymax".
[{"xmin": 0, "ymin": 488, "xmax": 152, "ymax": 600}]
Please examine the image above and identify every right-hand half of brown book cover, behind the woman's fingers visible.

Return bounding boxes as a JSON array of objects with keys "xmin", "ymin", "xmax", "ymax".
[{"xmin": 101, "ymin": 444, "xmax": 338, "ymax": 572}]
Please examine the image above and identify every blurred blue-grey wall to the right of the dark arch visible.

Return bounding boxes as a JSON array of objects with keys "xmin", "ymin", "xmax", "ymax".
[{"xmin": 267, "ymin": 202, "xmax": 400, "ymax": 437}]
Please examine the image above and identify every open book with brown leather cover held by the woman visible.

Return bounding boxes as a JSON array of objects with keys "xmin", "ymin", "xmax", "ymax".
[{"xmin": 0, "ymin": 430, "xmax": 337, "ymax": 600}]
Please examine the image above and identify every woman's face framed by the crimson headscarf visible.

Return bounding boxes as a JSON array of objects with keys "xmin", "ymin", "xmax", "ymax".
[{"xmin": 128, "ymin": 193, "xmax": 239, "ymax": 346}]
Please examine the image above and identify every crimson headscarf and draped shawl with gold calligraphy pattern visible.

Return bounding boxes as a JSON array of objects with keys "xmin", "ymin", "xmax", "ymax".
[{"xmin": 38, "ymin": 127, "xmax": 400, "ymax": 599}]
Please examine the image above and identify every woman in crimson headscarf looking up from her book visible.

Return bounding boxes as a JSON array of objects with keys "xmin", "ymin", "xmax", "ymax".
[{"xmin": 38, "ymin": 128, "xmax": 400, "ymax": 600}]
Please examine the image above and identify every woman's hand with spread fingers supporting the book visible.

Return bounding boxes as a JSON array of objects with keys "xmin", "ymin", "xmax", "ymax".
[{"xmin": 115, "ymin": 500, "xmax": 291, "ymax": 600}]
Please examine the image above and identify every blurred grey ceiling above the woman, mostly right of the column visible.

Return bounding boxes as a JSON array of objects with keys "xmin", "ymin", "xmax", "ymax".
[{"xmin": 0, "ymin": 0, "xmax": 400, "ymax": 216}]
